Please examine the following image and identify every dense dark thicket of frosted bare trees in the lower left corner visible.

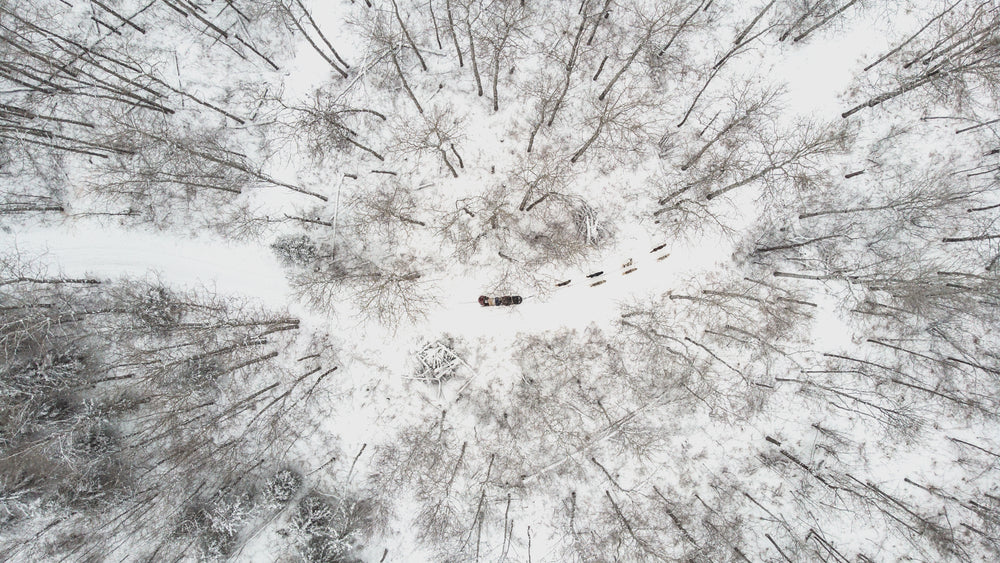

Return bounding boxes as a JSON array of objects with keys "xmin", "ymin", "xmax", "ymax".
[{"xmin": 0, "ymin": 261, "xmax": 374, "ymax": 560}]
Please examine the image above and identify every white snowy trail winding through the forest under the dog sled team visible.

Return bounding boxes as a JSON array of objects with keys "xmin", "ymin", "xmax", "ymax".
[{"xmin": 0, "ymin": 226, "xmax": 744, "ymax": 418}]
